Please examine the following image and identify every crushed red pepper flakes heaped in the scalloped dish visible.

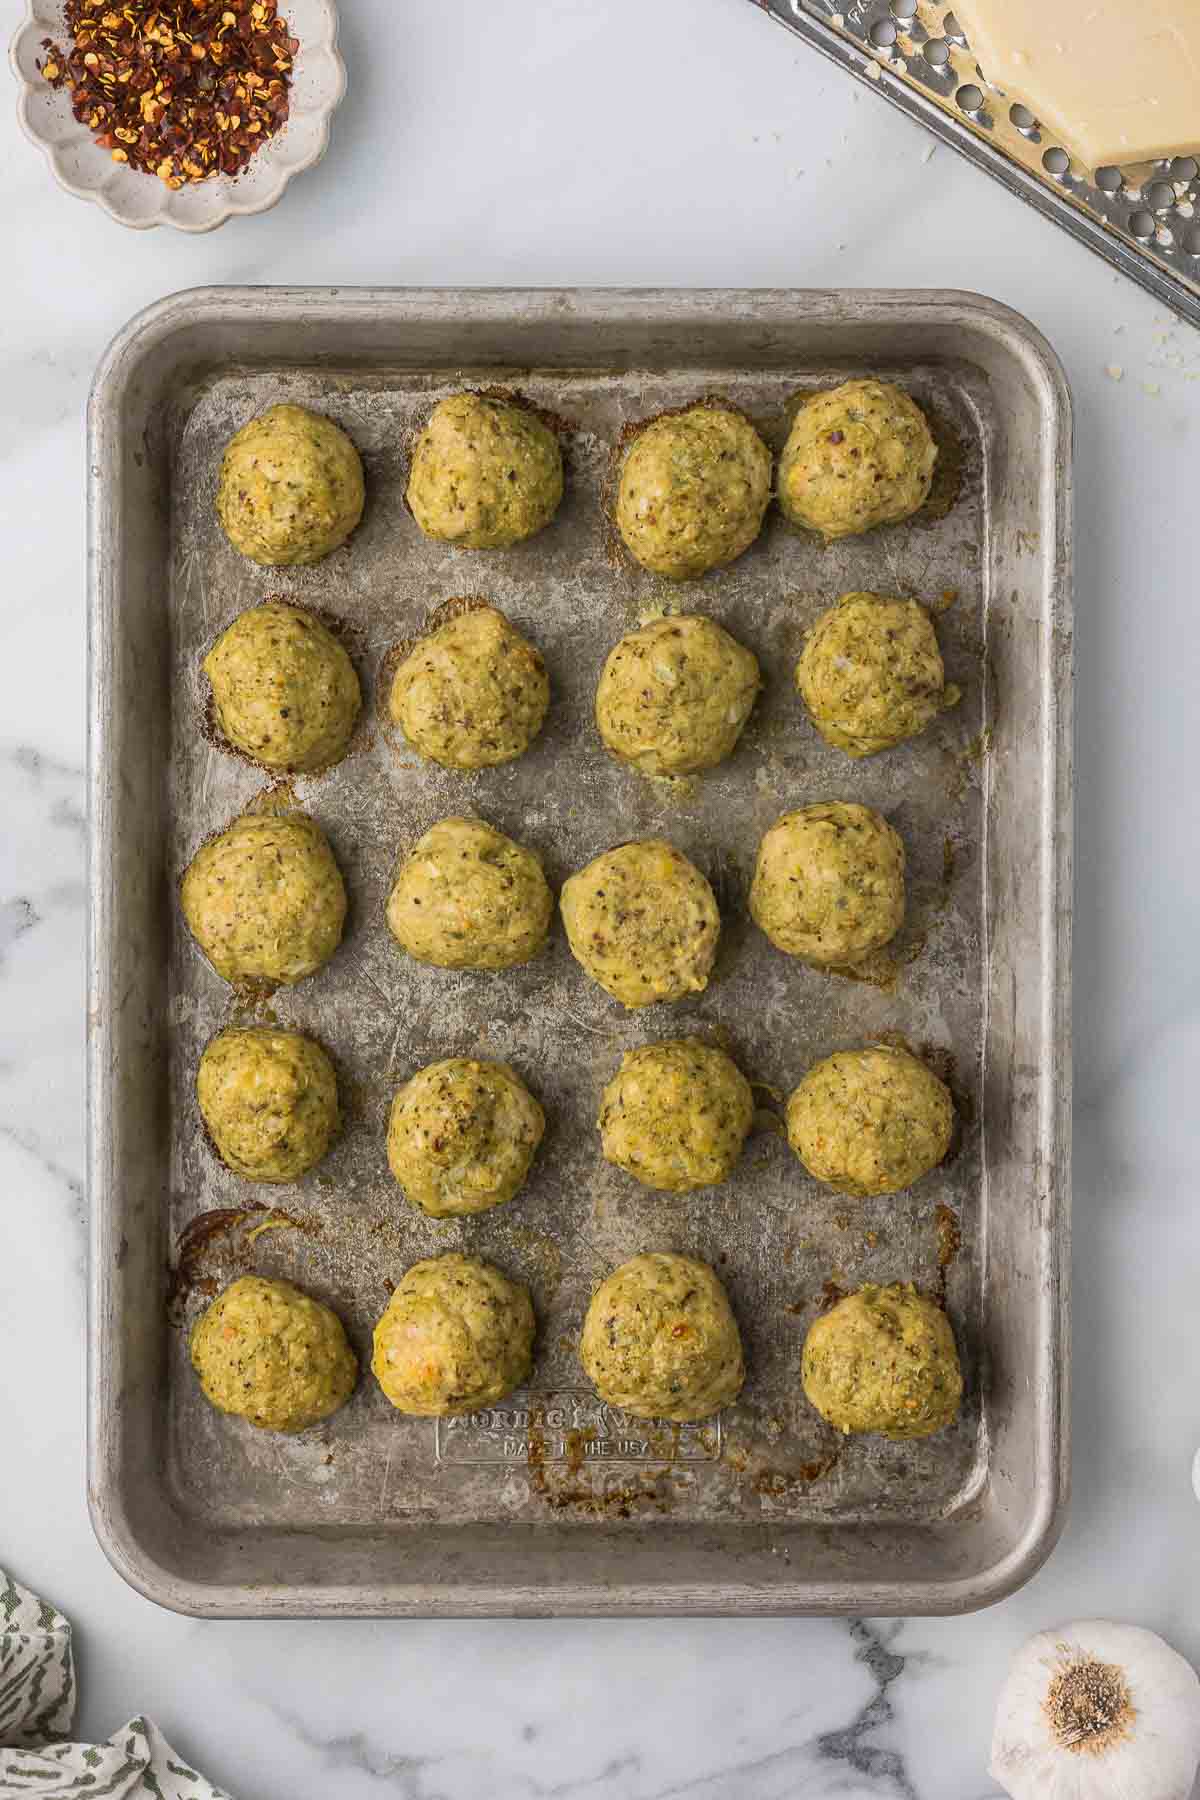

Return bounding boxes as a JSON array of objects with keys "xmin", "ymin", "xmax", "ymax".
[{"xmin": 38, "ymin": 0, "xmax": 300, "ymax": 187}]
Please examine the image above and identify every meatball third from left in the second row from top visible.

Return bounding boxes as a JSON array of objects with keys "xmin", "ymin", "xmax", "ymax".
[{"xmin": 596, "ymin": 612, "xmax": 761, "ymax": 776}]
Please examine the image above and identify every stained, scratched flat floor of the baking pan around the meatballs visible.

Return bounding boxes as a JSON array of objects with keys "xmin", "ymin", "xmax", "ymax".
[{"xmin": 89, "ymin": 284, "xmax": 1061, "ymax": 1609}]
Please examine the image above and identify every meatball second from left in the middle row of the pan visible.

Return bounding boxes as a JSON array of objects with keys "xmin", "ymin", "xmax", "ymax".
[{"xmin": 387, "ymin": 819, "xmax": 554, "ymax": 968}]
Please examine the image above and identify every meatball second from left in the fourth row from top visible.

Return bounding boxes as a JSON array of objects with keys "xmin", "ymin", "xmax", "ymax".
[{"xmin": 387, "ymin": 1057, "xmax": 545, "ymax": 1219}]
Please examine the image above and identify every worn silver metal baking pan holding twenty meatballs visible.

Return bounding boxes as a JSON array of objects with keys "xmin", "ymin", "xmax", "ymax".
[{"xmin": 90, "ymin": 288, "xmax": 1070, "ymax": 1615}]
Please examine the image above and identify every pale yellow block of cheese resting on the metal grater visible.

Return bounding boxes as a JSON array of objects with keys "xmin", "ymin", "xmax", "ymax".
[{"xmin": 954, "ymin": 0, "xmax": 1200, "ymax": 169}]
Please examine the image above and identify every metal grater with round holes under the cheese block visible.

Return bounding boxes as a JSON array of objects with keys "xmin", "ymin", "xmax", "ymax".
[{"xmin": 754, "ymin": 0, "xmax": 1200, "ymax": 326}]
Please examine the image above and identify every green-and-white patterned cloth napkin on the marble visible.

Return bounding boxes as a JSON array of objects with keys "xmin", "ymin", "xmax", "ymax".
[{"xmin": 0, "ymin": 1570, "xmax": 228, "ymax": 1800}]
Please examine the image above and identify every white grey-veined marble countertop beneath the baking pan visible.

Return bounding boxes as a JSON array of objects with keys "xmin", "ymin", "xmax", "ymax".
[{"xmin": 0, "ymin": 0, "xmax": 1200, "ymax": 1800}]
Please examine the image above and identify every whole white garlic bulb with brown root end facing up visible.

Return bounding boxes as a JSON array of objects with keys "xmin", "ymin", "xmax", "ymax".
[{"xmin": 990, "ymin": 1618, "xmax": 1200, "ymax": 1800}]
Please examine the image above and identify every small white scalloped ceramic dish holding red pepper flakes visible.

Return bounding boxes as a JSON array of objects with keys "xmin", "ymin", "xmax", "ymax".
[{"xmin": 9, "ymin": 0, "xmax": 345, "ymax": 232}]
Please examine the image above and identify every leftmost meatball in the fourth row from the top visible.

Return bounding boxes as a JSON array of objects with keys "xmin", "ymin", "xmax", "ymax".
[{"xmin": 196, "ymin": 1026, "xmax": 338, "ymax": 1181}]
